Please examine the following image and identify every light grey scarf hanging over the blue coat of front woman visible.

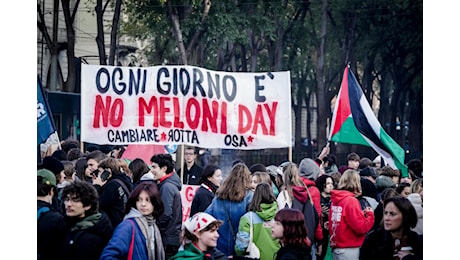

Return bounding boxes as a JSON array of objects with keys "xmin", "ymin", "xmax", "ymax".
[{"xmin": 135, "ymin": 216, "xmax": 165, "ymax": 260}]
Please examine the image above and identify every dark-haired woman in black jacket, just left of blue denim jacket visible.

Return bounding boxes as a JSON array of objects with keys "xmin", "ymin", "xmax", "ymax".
[{"xmin": 190, "ymin": 165, "xmax": 223, "ymax": 216}]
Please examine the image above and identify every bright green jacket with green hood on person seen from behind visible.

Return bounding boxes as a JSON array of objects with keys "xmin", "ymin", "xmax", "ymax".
[{"xmin": 235, "ymin": 202, "xmax": 280, "ymax": 260}]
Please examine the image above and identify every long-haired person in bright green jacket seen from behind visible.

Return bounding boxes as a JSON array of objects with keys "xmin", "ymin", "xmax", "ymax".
[{"xmin": 235, "ymin": 182, "xmax": 280, "ymax": 260}]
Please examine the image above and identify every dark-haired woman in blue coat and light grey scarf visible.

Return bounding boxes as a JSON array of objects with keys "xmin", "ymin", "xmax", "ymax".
[{"xmin": 101, "ymin": 182, "xmax": 165, "ymax": 260}]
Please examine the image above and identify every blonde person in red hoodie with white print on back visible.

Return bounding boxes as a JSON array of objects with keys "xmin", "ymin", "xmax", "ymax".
[{"xmin": 329, "ymin": 169, "xmax": 375, "ymax": 259}]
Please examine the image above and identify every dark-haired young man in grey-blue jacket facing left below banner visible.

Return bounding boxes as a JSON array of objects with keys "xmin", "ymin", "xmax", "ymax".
[{"xmin": 149, "ymin": 154, "xmax": 182, "ymax": 259}]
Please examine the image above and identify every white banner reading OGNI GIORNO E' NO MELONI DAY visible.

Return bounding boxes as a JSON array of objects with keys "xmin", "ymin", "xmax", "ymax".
[{"xmin": 81, "ymin": 64, "xmax": 292, "ymax": 150}]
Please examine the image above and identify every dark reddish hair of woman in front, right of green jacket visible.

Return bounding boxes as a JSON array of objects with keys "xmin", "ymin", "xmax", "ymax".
[{"xmin": 275, "ymin": 208, "xmax": 311, "ymax": 247}]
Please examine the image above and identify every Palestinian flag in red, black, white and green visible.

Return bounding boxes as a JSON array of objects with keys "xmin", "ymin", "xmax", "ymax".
[{"xmin": 329, "ymin": 67, "xmax": 407, "ymax": 176}]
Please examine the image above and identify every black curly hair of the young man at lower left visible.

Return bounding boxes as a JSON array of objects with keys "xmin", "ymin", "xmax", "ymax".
[{"xmin": 62, "ymin": 180, "xmax": 99, "ymax": 216}]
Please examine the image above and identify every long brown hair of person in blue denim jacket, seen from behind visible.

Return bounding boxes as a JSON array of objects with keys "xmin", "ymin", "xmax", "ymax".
[{"xmin": 216, "ymin": 163, "xmax": 251, "ymax": 202}]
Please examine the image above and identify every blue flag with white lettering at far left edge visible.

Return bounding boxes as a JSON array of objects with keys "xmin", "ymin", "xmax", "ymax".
[{"xmin": 37, "ymin": 78, "xmax": 56, "ymax": 145}]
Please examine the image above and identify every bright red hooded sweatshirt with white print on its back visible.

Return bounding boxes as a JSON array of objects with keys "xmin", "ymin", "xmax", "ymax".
[{"xmin": 329, "ymin": 190, "xmax": 374, "ymax": 248}]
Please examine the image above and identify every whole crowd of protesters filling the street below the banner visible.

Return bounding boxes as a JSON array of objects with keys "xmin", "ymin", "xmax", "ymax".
[{"xmin": 37, "ymin": 140, "xmax": 423, "ymax": 260}]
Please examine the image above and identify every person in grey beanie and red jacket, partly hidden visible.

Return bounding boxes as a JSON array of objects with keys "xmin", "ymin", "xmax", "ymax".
[{"xmin": 299, "ymin": 158, "xmax": 323, "ymax": 259}]
